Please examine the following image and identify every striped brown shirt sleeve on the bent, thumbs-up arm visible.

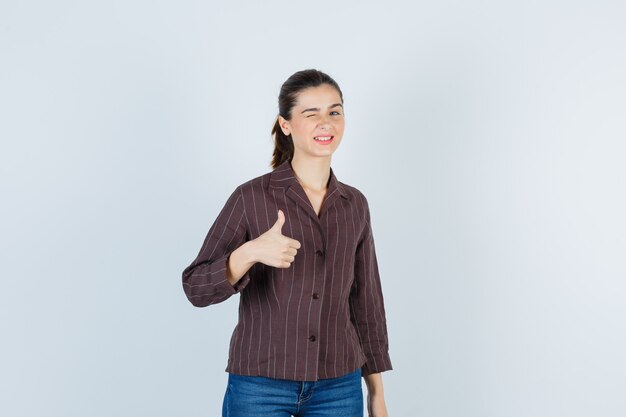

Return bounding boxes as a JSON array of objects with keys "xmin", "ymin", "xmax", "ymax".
[{"xmin": 182, "ymin": 187, "xmax": 252, "ymax": 307}]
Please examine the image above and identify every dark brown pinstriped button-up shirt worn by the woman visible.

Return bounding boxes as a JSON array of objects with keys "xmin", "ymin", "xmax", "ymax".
[{"xmin": 182, "ymin": 160, "xmax": 392, "ymax": 381}]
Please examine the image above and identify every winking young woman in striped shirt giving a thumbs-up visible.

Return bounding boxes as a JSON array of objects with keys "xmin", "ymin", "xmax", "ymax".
[{"xmin": 182, "ymin": 69, "xmax": 392, "ymax": 417}]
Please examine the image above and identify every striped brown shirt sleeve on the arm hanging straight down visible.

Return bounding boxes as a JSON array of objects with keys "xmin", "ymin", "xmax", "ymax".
[{"xmin": 349, "ymin": 196, "xmax": 393, "ymax": 376}]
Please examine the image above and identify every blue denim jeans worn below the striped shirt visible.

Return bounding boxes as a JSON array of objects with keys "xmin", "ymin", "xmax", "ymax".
[{"xmin": 222, "ymin": 369, "xmax": 363, "ymax": 417}]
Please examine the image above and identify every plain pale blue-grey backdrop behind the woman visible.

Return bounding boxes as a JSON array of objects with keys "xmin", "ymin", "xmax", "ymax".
[{"xmin": 0, "ymin": 0, "xmax": 626, "ymax": 417}]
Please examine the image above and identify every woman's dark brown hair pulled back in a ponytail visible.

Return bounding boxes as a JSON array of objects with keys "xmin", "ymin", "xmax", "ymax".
[{"xmin": 272, "ymin": 69, "xmax": 343, "ymax": 168}]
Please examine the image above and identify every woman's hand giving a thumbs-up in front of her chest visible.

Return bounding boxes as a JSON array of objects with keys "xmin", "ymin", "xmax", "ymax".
[{"xmin": 252, "ymin": 210, "xmax": 300, "ymax": 268}]
